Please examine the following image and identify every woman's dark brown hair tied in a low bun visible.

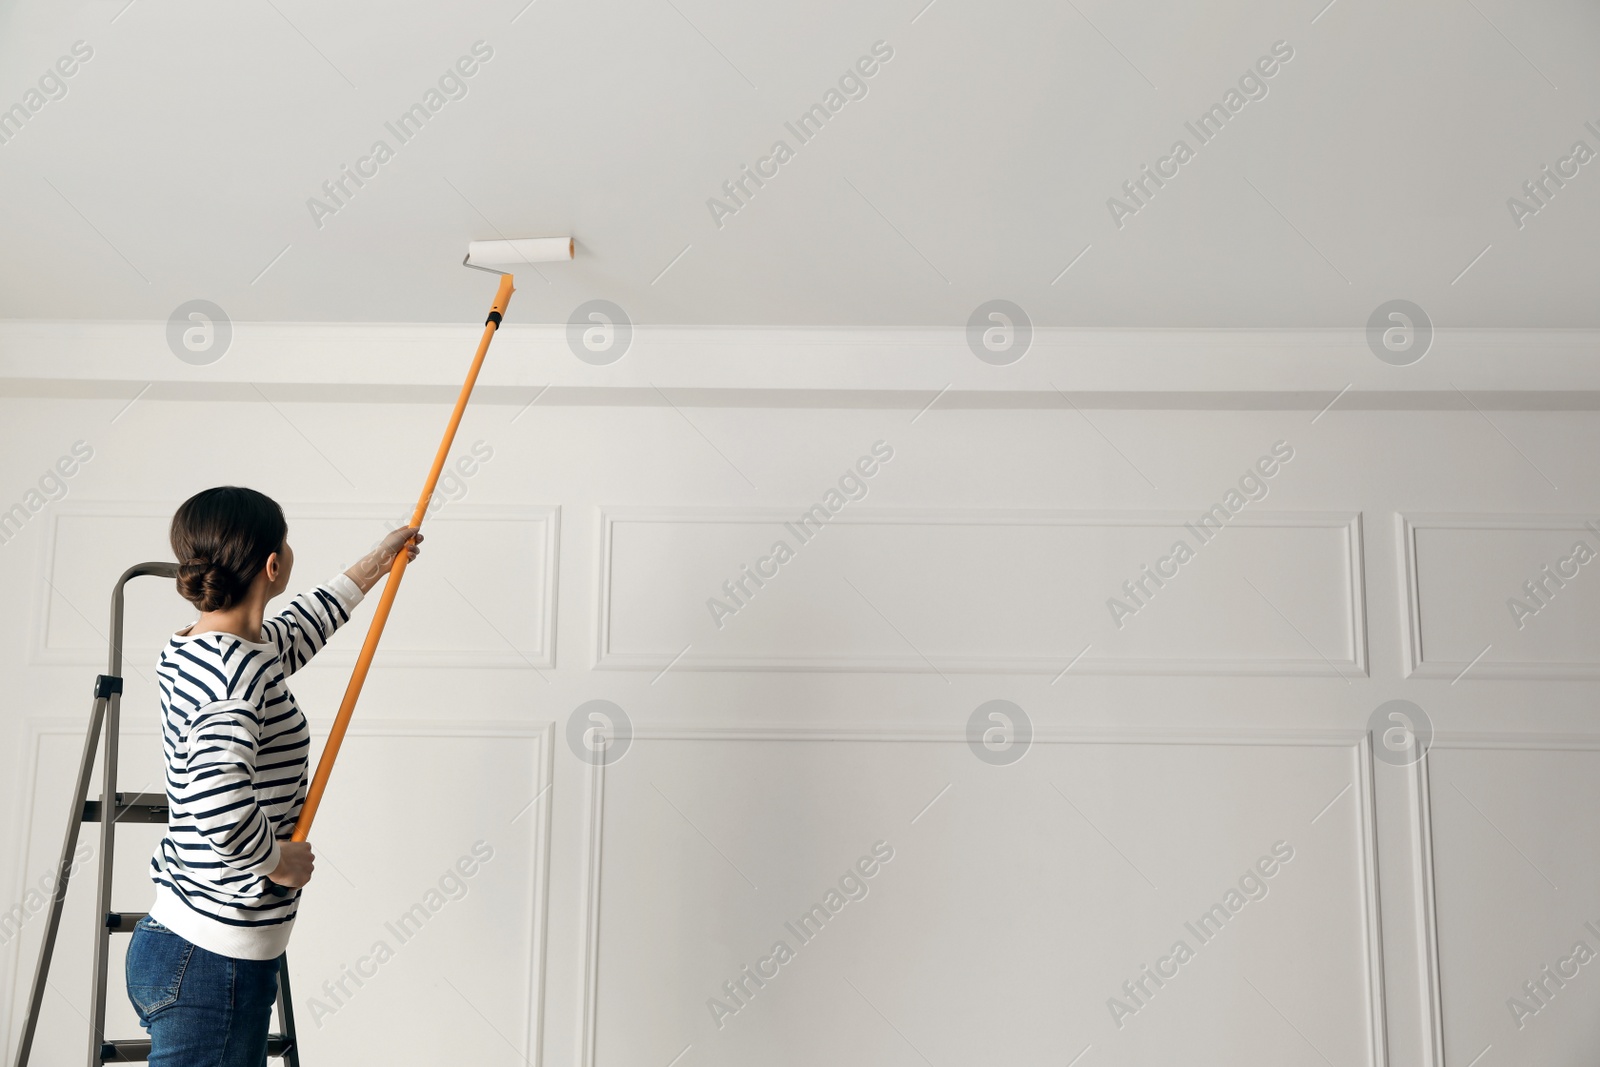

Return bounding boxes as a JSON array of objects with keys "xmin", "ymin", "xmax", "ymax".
[{"xmin": 171, "ymin": 485, "xmax": 290, "ymax": 611}]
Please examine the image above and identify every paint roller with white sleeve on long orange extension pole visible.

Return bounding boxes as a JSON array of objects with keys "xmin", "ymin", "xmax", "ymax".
[{"xmin": 272, "ymin": 237, "xmax": 576, "ymax": 896}]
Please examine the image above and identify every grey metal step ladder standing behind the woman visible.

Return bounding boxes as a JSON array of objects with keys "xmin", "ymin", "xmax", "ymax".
[{"xmin": 14, "ymin": 563, "xmax": 299, "ymax": 1067}]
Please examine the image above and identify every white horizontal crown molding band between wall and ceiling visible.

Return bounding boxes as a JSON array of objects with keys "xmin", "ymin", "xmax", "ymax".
[{"xmin": 0, "ymin": 318, "xmax": 1600, "ymax": 410}]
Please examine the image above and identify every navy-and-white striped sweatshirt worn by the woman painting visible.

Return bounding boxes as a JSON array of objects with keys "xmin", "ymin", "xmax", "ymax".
[{"xmin": 150, "ymin": 574, "xmax": 362, "ymax": 960}]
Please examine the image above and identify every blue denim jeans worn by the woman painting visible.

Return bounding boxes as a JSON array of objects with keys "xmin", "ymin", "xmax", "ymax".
[{"xmin": 126, "ymin": 918, "xmax": 278, "ymax": 1067}]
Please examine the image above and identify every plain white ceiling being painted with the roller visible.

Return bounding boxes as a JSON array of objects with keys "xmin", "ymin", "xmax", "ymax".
[{"xmin": 0, "ymin": 0, "xmax": 1600, "ymax": 328}]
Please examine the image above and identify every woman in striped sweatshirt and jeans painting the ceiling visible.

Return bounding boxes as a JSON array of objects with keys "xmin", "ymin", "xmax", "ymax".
[{"xmin": 126, "ymin": 486, "xmax": 422, "ymax": 1067}]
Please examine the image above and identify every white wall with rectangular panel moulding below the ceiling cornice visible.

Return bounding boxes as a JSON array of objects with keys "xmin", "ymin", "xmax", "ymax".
[{"xmin": 0, "ymin": 326, "xmax": 1600, "ymax": 1067}]
